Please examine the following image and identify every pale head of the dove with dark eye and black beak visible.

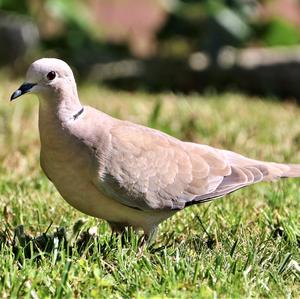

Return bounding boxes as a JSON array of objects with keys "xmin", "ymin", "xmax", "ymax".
[{"xmin": 10, "ymin": 58, "xmax": 77, "ymax": 101}]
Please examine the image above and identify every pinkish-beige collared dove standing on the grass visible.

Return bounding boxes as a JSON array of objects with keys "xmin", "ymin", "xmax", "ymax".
[{"xmin": 11, "ymin": 58, "xmax": 300, "ymax": 241}]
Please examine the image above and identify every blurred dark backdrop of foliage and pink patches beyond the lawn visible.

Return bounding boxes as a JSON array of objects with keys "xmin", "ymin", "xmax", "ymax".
[{"xmin": 0, "ymin": 0, "xmax": 300, "ymax": 99}]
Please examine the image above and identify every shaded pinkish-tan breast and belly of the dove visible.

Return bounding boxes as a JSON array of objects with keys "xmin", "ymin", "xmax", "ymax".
[{"xmin": 40, "ymin": 115, "xmax": 172, "ymax": 230}]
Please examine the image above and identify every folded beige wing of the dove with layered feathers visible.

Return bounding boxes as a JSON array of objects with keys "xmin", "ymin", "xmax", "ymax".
[{"xmin": 93, "ymin": 122, "xmax": 278, "ymax": 210}]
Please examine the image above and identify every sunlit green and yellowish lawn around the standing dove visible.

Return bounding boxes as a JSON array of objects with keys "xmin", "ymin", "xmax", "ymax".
[{"xmin": 0, "ymin": 76, "xmax": 300, "ymax": 299}]
